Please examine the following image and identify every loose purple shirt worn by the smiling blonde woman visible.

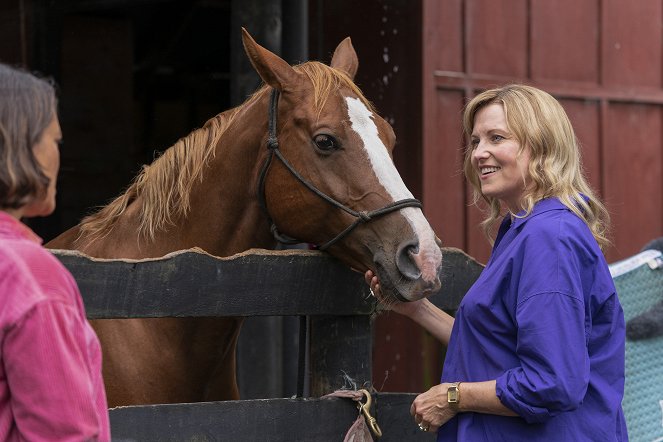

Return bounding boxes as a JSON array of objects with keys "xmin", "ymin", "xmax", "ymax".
[{"xmin": 438, "ymin": 198, "xmax": 628, "ymax": 442}]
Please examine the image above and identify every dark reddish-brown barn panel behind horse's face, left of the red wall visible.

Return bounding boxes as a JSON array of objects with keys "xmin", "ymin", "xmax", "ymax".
[{"xmin": 309, "ymin": 0, "xmax": 421, "ymax": 197}]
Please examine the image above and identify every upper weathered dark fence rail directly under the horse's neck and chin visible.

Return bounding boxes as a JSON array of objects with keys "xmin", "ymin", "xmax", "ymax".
[{"xmin": 53, "ymin": 248, "xmax": 483, "ymax": 319}]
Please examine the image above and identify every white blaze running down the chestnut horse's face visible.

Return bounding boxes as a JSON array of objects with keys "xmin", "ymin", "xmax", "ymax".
[{"xmin": 345, "ymin": 97, "xmax": 442, "ymax": 281}]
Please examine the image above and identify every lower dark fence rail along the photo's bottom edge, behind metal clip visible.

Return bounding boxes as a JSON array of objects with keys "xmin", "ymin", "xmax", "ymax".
[{"xmin": 110, "ymin": 393, "xmax": 435, "ymax": 442}]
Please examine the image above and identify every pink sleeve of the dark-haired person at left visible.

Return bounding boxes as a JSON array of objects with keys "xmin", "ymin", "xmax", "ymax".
[{"xmin": 2, "ymin": 301, "xmax": 100, "ymax": 441}]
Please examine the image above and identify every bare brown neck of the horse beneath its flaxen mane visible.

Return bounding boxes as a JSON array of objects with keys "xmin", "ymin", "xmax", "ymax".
[{"xmin": 65, "ymin": 97, "xmax": 275, "ymax": 258}]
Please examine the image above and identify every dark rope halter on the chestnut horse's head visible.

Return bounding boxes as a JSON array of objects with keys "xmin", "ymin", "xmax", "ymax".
[{"xmin": 258, "ymin": 89, "xmax": 421, "ymax": 250}]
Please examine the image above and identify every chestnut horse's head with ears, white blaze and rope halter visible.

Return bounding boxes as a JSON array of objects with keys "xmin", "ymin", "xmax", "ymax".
[{"xmin": 243, "ymin": 31, "xmax": 442, "ymax": 301}]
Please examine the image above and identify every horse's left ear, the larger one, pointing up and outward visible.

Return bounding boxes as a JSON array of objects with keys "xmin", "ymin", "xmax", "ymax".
[{"xmin": 242, "ymin": 28, "xmax": 298, "ymax": 91}]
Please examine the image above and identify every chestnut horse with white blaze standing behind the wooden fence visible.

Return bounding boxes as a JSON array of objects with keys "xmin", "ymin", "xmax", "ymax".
[{"xmin": 47, "ymin": 30, "xmax": 442, "ymax": 406}]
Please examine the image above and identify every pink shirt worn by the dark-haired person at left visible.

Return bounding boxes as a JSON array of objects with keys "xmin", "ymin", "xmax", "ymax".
[{"xmin": 0, "ymin": 211, "xmax": 110, "ymax": 441}]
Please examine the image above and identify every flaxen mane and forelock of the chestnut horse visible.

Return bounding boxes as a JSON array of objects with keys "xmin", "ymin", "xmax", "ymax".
[{"xmin": 78, "ymin": 62, "xmax": 373, "ymax": 241}]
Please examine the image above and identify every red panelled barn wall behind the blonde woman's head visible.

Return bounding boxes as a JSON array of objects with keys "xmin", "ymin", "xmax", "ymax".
[{"xmin": 422, "ymin": 0, "xmax": 663, "ymax": 262}]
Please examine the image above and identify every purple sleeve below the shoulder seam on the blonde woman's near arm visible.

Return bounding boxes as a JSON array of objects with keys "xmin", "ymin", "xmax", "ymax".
[{"xmin": 496, "ymin": 292, "xmax": 589, "ymax": 423}]
